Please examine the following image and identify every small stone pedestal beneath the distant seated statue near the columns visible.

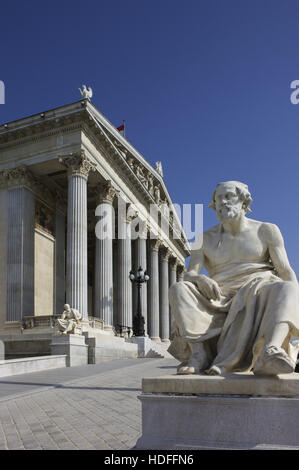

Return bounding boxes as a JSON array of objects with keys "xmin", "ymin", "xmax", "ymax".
[{"xmin": 51, "ymin": 334, "xmax": 88, "ymax": 367}]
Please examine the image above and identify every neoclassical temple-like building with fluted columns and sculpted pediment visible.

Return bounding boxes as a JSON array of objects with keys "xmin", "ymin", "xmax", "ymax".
[{"xmin": 0, "ymin": 99, "xmax": 189, "ymax": 356}]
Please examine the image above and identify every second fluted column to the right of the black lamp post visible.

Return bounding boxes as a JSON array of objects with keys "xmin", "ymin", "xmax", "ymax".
[{"xmin": 160, "ymin": 246, "xmax": 170, "ymax": 341}]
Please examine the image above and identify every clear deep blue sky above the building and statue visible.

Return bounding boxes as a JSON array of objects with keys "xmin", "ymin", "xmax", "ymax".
[{"xmin": 0, "ymin": 0, "xmax": 299, "ymax": 276}]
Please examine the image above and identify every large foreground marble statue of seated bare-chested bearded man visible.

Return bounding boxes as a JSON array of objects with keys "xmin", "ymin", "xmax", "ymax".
[{"xmin": 169, "ymin": 181, "xmax": 299, "ymax": 375}]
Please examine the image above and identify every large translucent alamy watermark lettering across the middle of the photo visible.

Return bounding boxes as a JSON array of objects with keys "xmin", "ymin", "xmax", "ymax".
[{"xmin": 95, "ymin": 197, "xmax": 203, "ymax": 250}]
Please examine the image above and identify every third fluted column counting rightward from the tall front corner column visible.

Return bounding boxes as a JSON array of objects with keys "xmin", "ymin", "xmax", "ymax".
[{"xmin": 117, "ymin": 201, "xmax": 137, "ymax": 328}]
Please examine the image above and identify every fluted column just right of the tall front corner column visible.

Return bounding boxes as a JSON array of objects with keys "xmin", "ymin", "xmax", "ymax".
[{"xmin": 94, "ymin": 181, "xmax": 116, "ymax": 329}]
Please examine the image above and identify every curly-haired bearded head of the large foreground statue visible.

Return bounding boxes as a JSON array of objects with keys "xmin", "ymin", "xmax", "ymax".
[{"xmin": 209, "ymin": 181, "xmax": 252, "ymax": 222}]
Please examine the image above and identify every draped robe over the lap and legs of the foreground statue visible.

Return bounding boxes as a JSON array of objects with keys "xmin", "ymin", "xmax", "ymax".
[{"xmin": 168, "ymin": 262, "xmax": 299, "ymax": 372}]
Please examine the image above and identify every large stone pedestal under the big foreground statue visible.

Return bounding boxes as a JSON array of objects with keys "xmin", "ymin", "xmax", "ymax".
[{"xmin": 136, "ymin": 373, "xmax": 299, "ymax": 450}]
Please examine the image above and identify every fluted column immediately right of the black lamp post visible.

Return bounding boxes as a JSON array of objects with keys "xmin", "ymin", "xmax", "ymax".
[{"xmin": 148, "ymin": 239, "xmax": 161, "ymax": 341}]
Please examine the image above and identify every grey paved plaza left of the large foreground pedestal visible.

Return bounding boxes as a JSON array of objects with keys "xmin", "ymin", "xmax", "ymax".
[{"xmin": 0, "ymin": 358, "xmax": 178, "ymax": 450}]
